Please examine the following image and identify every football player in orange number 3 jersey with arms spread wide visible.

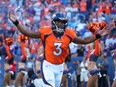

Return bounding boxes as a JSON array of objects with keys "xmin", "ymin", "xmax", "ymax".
[{"xmin": 9, "ymin": 12, "xmax": 110, "ymax": 87}]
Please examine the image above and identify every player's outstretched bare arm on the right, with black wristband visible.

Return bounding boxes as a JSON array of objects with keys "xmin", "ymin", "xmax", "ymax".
[{"xmin": 73, "ymin": 25, "xmax": 110, "ymax": 44}]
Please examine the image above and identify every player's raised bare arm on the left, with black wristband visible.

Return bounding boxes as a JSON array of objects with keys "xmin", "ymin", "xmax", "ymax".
[{"xmin": 8, "ymin": 13, "xmax": 40, "ymax": 38}]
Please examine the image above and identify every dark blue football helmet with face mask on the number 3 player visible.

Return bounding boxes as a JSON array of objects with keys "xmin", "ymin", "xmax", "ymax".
[{"xmin": 52, "ymin": 12, "xmax": 68, "ymax": 33}]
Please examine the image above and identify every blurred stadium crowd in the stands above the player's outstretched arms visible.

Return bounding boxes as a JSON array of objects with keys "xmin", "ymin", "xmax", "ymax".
[{"xmin": 0, "ymin": 0, "xmax": 116, "ymax": 37}]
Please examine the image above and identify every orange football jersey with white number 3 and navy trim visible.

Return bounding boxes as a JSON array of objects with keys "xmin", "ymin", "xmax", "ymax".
[{"xmin": 39, "ymin": 26, "xmax": 76, "ymax": 64}]
